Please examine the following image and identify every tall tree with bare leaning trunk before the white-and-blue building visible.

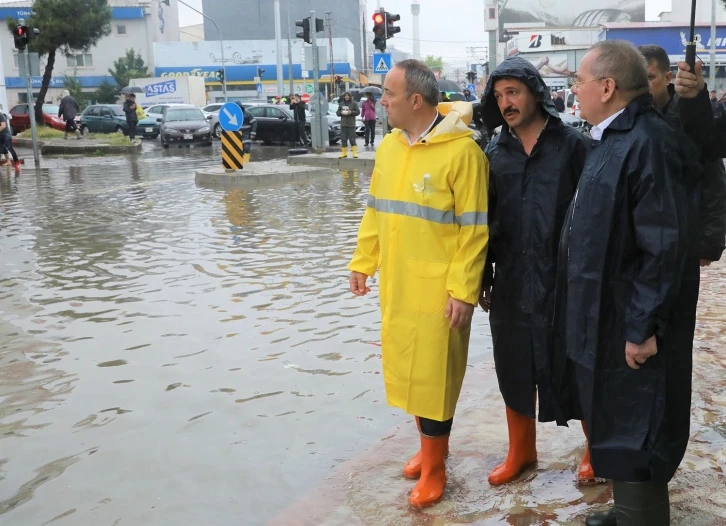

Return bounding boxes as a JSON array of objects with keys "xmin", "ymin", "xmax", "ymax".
[{"xmin": 8, "ymin": 0, "xmax": 111, "ymax": 124}]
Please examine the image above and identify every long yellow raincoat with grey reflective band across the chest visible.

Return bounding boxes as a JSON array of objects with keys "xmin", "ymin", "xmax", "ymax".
[{"xmin": 349, "ymin": 102, "xmax": 489, "ymax": 421}]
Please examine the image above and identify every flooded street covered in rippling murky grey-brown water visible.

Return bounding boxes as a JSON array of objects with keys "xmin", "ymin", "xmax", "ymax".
[{"xmin": 0, "ymin": 142, "xmax": 726, "ymax": 526}]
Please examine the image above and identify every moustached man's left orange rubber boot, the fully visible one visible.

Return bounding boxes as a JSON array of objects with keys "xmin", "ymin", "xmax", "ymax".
[{"xmin": 489, "ymin": 407, "xmax": 537, "ymax": 486}]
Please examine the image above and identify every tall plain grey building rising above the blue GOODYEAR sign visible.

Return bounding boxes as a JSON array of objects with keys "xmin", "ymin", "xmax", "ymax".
[{"xmin": 202, "ymin": 0, "xmax": 368, "ymax": 71}]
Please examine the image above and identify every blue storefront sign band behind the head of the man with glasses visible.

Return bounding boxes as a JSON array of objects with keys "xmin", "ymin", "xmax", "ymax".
[{"xmin": 600, "ymin": 24, "xmax": 726, "ymax": 65}]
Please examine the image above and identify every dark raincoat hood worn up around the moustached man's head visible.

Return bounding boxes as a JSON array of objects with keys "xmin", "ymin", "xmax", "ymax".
[{"xmin": 482, "ymin": 57, "xmax": 560, "ymax": 129}]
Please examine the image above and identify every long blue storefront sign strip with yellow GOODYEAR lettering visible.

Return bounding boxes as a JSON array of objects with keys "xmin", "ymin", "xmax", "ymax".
[{"xmin": 155, "ymin": 62, "xmax": 351, "ymax": 83}]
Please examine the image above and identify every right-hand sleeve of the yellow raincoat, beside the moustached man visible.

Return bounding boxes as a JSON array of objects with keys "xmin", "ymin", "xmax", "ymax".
[{"xmin": 446, "ymin": 141, "xmax": 489, "ymax": 305}]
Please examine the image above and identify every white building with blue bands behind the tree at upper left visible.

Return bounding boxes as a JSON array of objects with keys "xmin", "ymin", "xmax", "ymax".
[{"xmin": 0, "ymin": 0, "xmax": 179, "ymax": 109}]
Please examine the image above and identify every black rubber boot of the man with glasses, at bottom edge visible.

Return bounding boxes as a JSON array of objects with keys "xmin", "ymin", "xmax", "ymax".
[{"xmin": 613, "ymin": 481, "xmax": 671, "ymax": 526}]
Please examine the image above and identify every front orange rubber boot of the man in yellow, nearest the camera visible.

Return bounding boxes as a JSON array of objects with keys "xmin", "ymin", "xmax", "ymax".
[{"xmin": 408, "ymin": 434, "xmax": 449, "ymax": 508}]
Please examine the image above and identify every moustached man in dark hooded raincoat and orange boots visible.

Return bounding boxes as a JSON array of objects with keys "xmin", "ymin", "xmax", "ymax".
[{"xmin": 482, "ymin": 57, "xmax": 594, "ymax": 485}]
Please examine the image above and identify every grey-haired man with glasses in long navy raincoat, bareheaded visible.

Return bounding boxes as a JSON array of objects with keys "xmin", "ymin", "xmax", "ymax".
[{"xmin": 552, "ymin": 40, "xmax": 693, "ymax": 526}]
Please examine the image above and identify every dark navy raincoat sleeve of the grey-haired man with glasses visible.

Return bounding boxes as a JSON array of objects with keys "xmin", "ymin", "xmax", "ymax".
[{"xmin": 625, "ymin": 138, "xmax": 686, "ymax": 344}]
